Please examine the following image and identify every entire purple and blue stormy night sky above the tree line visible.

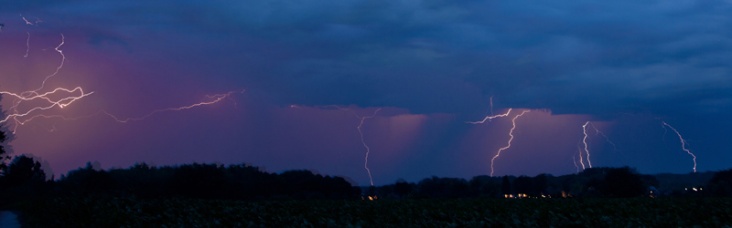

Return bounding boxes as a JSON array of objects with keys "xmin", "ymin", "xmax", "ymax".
[{"xmin": 0, "ymin": 0, "xmax": 732, "ymax": 185}]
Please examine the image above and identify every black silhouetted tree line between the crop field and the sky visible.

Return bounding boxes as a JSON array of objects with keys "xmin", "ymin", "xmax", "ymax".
[{"xmin": 0, "ymin": 155, "xmax": 732, "ymax": 203}]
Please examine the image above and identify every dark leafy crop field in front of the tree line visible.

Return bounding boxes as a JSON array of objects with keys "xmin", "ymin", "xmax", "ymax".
[{"xmin": 14, "ymin": 197, "xmax": 732, "ymax": 227}]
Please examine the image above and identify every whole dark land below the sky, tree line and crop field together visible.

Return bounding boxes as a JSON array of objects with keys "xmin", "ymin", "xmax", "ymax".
[{"xmin": 0, "ymin": 156, "xmax": 732, "ymax": 227}]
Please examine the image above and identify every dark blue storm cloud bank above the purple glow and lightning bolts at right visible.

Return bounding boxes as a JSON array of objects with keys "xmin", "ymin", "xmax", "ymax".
[{"xmin": 11, "ymin": 0, "xmax": 732, "ymax": 114}]
